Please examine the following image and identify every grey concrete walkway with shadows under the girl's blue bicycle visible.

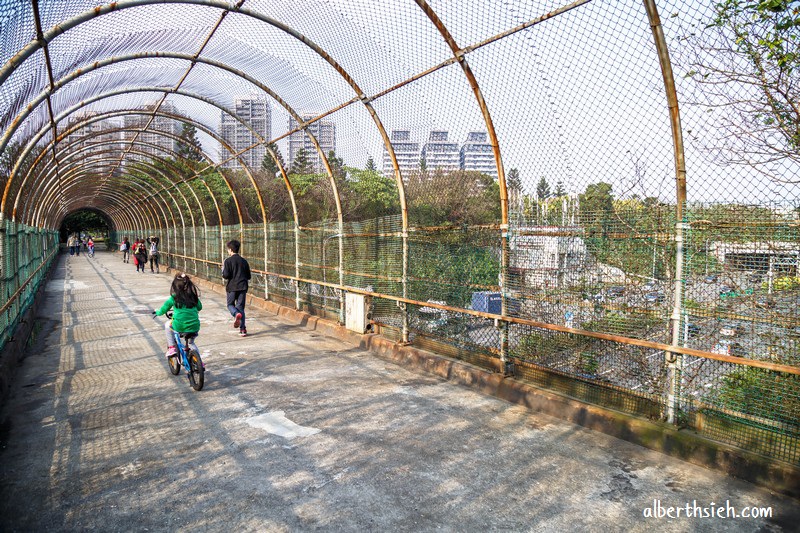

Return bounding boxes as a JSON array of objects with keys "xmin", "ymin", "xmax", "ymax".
[{"xmin": 0, "ymin": 253, "xmax": 800, "ymax": 531}]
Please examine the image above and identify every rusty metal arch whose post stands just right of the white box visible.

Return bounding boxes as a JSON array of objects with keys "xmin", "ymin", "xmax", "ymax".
[{"xmin": 0, "ymin": 0, "xmax": 409, "ymax": 324}]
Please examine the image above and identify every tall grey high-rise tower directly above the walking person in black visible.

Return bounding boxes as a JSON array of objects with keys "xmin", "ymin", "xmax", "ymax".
[{"xmin": 220, "ymin": 97, "xmax": 272, "ymax": 170}]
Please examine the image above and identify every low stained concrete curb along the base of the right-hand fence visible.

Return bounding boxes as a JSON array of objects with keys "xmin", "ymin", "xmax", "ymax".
[{"xmin": 178, "ymin": 268, "xmax": 800, "ymax": 498}]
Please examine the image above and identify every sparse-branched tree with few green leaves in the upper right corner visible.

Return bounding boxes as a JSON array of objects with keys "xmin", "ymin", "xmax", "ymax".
[{"xmin": 683, "ymin": 0, "xmax": 800, "ymax": 181}]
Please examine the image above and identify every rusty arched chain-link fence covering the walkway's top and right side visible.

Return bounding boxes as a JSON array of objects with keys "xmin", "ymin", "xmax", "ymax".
[{"xmin": 0, "ymin": 0, "xmax": 800, "ymax": 464}]
